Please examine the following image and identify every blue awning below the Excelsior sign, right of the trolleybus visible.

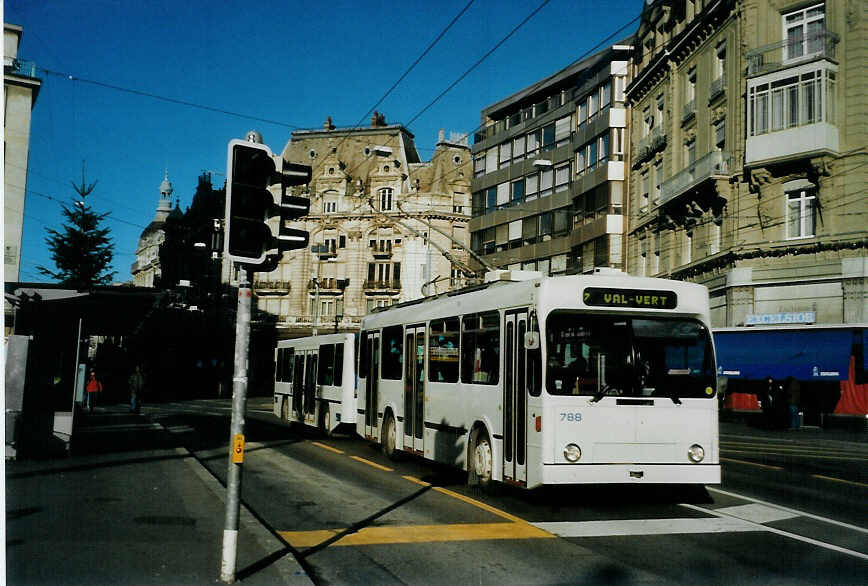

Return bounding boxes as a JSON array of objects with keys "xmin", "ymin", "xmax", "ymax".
[{"xmin": 714, "ymin": 328, "xmax": 853, "ymax": 381}]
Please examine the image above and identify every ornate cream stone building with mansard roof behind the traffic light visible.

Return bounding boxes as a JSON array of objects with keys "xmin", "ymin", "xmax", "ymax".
[{"xmin": 242, "ymin": 112, "xmax": 471, "ymax": 336}]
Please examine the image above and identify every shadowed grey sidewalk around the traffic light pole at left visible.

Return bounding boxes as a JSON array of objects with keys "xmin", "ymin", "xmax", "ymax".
[{"xmin": 6, "ymin": 405, "xmax": 311, "ymax": 585}]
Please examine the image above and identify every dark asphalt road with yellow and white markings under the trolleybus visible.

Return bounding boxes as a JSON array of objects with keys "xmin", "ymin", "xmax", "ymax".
[{"xmin": 149, "ymin": 398, "xmax": 868, "ymax": 584}]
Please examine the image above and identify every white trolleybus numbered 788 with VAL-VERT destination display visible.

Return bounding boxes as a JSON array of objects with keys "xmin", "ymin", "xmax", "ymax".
[{"xmin": 356, "ymin": 271, "xmax": 720, "ymax": 488}]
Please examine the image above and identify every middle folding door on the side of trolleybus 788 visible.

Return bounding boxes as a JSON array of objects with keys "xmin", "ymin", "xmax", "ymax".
[{"xmin": 404, "ymin": 325, "xmax": 425, "ymax": 453}]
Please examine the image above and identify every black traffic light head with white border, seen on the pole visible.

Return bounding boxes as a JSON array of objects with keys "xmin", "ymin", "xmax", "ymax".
[{"xmin": 224, "ymin": 140, "xmax": 311, "ymax": 271}]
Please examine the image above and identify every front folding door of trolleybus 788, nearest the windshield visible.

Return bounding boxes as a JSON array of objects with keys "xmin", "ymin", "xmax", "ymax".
[{"xmin": 503, "ymin": 309, "xmax": 527, "ymax": 484}]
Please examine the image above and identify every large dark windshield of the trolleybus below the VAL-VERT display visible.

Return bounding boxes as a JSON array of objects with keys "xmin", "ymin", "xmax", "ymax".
[{"xmin": 546, "ymin": 311, "xmax": 716, "ymax": 402}]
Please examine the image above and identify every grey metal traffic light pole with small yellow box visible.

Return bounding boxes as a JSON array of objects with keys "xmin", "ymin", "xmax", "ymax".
[{"xmin": 220, "ymin": 265, "xmax": 253, "ymax": 584}]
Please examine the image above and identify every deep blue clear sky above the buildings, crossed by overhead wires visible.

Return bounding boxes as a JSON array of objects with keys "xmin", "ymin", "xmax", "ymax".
[{"xmin": 4, "ymin": 0, "xmax": 643, "ymax": 281}]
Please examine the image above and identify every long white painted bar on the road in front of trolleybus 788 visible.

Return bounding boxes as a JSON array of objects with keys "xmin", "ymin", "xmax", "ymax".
[{"xmin": 534, "ymin": 517, "xmax": 762, "ymax": 537}]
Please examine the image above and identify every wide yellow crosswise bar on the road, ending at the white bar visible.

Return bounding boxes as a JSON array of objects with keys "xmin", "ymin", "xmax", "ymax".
[{"xmin": 278, "ymin": 523, "xmax": 554, "ymax": 548}]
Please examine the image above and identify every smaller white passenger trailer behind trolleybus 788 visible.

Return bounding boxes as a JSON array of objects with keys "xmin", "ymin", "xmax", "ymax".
[{"xmin": 274, "ymin": 334, "xmax": 356, "ymax": 434}]
